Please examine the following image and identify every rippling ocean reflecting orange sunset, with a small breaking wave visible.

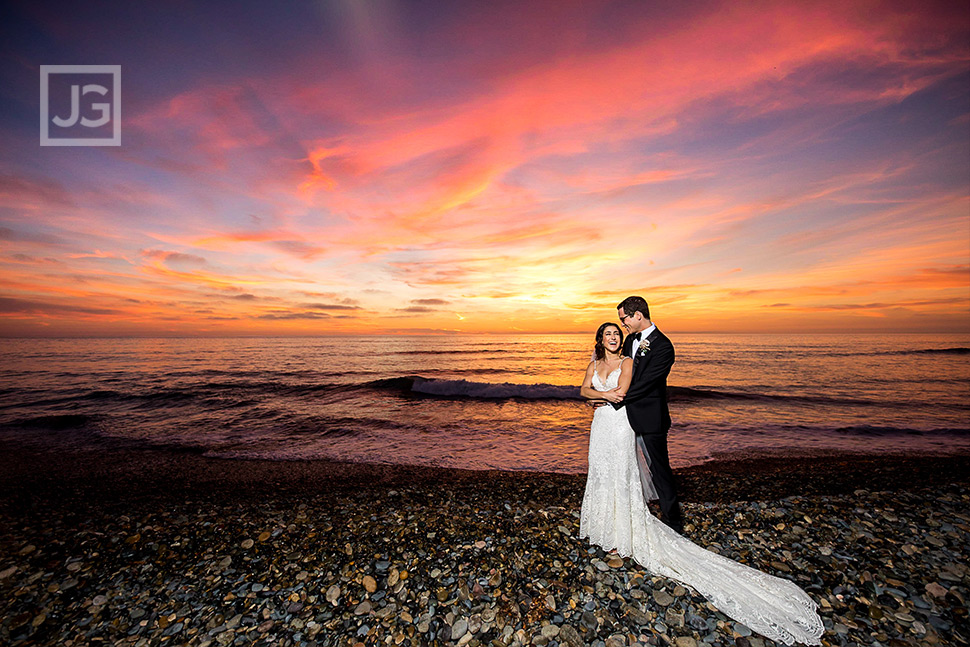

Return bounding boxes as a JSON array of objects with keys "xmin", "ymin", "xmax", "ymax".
[{"xmin": 0, "ymin": 333, "xmax": 970, "ymax": 473}]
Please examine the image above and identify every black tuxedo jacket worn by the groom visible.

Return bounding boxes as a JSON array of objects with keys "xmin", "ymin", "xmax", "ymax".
[{"xmin": 613, "ymin": 328, "xmax": 674, "ymax": 436}]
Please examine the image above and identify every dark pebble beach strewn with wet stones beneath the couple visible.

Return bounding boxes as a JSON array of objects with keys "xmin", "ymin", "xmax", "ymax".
[{"xmin": 0, "ymin": 446, "xmax": 970, "ymax": 647}]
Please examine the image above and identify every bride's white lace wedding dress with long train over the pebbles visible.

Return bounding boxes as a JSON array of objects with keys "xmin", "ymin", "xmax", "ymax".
[{"xmin": 579, "ymin": 369, "xmax": 823, "ymax": 645}]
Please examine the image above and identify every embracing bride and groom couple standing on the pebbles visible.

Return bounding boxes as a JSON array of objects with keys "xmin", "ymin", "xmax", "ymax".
[{"xmin": 580, "ymin": 296, "xmax": 823, "ymax": 645}]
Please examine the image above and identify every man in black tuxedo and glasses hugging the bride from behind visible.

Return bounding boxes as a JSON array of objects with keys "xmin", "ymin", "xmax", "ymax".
[{"xmin": 613, "ymin": 296, "xmax": 684, "ymax": 534}]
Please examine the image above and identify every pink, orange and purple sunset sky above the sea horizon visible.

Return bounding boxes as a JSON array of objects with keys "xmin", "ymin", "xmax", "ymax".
[{"xmin": 0, "ymin": 0, "xmax": 970, "ymax": 337}]
